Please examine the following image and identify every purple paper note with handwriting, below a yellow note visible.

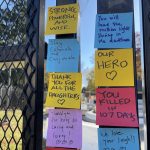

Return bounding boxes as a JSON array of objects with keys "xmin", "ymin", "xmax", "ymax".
[{"xmin": 46, "ymin": 109, "xmax": 82, "ymax": 148}]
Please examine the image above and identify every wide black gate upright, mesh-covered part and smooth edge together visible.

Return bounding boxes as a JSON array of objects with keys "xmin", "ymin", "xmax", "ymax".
[{"xmin": 22, "ymin": 0, "xmax": 45, "ymax": 150}]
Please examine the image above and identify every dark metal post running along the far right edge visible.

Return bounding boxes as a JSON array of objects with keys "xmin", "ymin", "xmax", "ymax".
[{"xmin": 142, "ymin": 0, "xmax": 150, "ymax": 150}]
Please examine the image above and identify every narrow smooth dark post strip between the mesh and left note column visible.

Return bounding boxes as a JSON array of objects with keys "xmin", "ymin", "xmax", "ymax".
[{"xmin": 34, "ymin": 0, "xmax": 45, "ymax": 150}]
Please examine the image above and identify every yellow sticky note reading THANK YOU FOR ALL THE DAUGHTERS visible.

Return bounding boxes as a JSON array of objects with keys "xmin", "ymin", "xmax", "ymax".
[{"xmin": 45, "ymin": 73, "xmax": 82, "ymax": 109}]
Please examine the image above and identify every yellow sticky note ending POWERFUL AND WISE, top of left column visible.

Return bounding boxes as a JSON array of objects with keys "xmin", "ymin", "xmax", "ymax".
[{"xmin": 45, "ymin": 4, "xmax": 79, "ymax": 35}]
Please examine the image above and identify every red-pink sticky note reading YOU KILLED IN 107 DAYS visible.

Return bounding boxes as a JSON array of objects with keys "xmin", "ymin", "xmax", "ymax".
[{"xmin": 96, "ymin": 88, "xmax": 138, "ymax": 127}]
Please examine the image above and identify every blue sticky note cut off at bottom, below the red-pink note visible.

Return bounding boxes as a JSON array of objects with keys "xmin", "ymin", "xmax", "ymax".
[{"xmin": 98, "ymin": 128, "xmax": 140, "ymax": 150}]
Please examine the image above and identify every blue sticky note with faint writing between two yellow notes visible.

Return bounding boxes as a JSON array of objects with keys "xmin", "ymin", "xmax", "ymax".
[{"xmin": 46, "ymin": 39, "xmax": 80, "ymax": 72}]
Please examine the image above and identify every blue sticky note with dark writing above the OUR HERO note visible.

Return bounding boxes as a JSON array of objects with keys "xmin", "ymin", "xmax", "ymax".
[{"xmin": 95, "ymin": 13, "xmax": 133, "ymax": 48}]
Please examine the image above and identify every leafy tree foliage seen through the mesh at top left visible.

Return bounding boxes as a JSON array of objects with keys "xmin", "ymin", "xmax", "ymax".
[{"xmin": 0, "ymin": 0, "xmax": 27, "ymax": 46}]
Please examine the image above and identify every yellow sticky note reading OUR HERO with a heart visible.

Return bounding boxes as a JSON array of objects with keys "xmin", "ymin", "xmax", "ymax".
[{"xmin": 95, "ymin": 49, "xmax": 134, "ymax": 87}]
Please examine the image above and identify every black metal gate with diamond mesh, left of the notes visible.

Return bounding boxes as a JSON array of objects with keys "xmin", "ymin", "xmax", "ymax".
[{"xmin": 0, "ymin": 0, "xmax": 44, "ymax": 150}]
